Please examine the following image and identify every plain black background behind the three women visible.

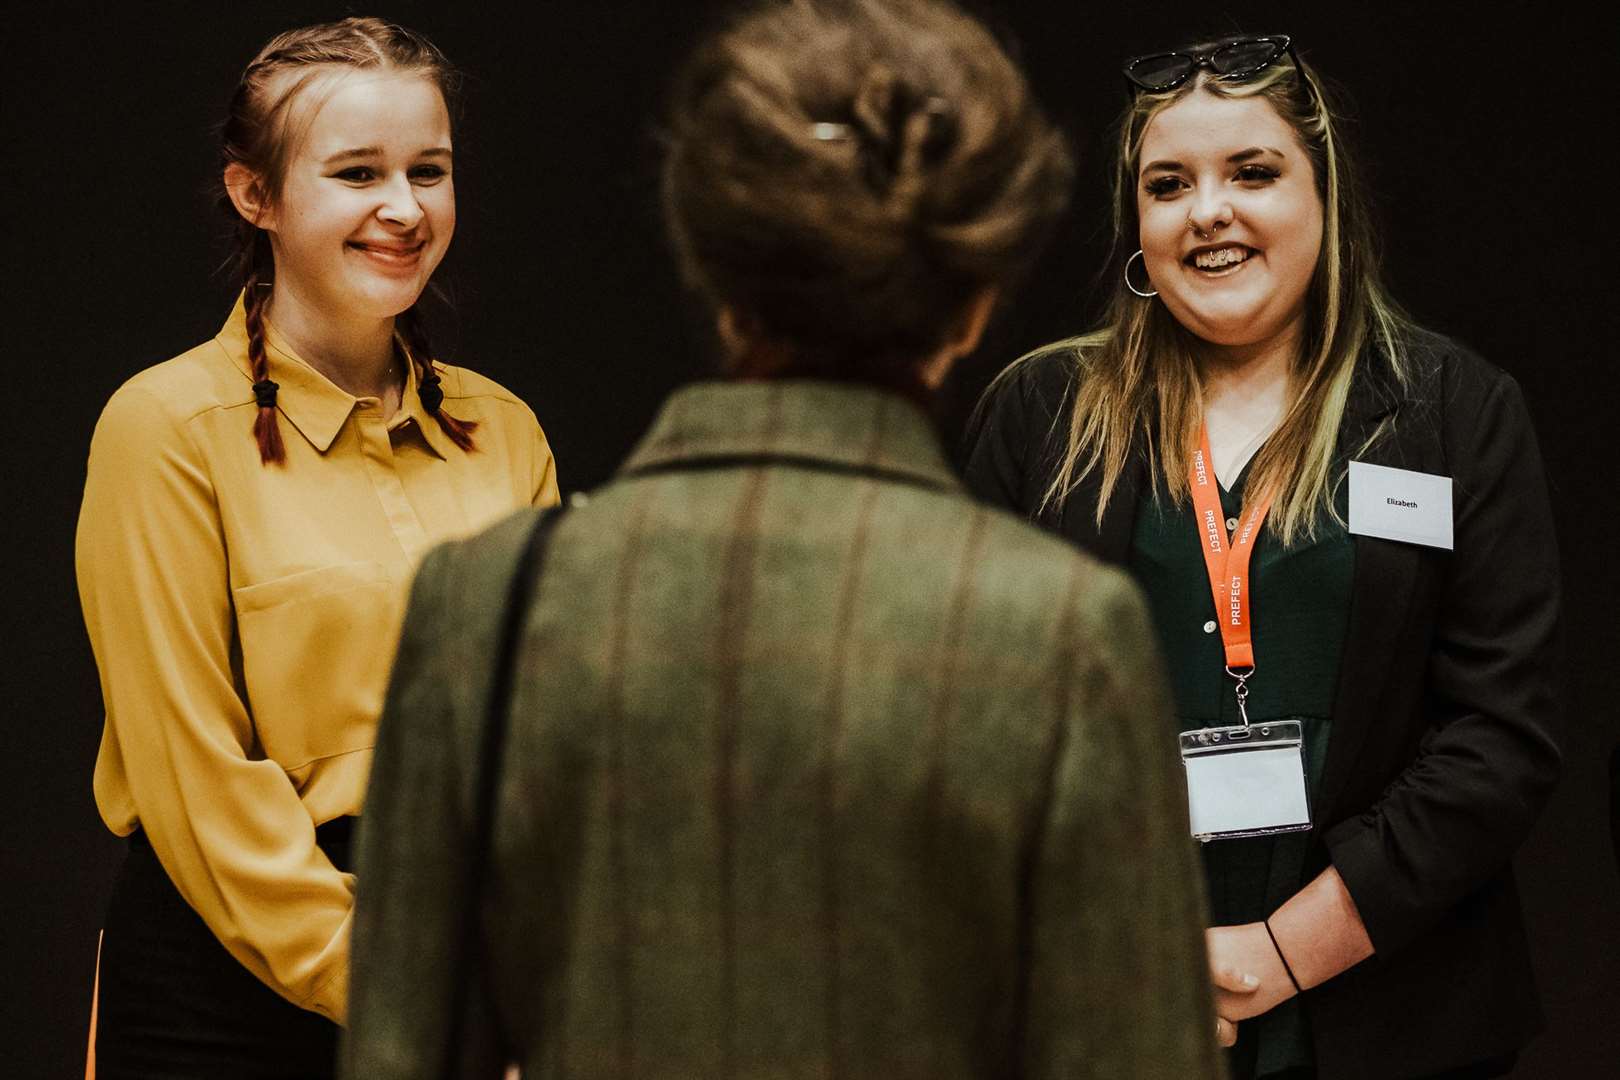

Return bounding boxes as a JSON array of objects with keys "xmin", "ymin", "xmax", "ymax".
[{"xmin": 0, "ymin": 2, "xmax": 1620, "ymax": 1078}]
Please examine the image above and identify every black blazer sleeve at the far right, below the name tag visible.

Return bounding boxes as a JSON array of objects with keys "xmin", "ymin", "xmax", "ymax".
[{"xmin": 1325, "ymin": 361, "xmax": 1562, "ymax": 952}]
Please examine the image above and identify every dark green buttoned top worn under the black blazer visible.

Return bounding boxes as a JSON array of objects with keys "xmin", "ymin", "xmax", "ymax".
[{"xmin": 1129, "ymin": 470, "xmax": 1354, "ymax": 1078}]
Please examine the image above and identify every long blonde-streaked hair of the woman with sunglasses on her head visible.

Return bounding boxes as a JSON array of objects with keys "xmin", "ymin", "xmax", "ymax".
[{"xmin": 998, "ymin": 46, "xmax": 1411, "ymax": 544}]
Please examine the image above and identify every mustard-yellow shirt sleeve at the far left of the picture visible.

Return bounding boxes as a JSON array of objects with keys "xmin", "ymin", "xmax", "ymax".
[{"xmin": 76, "ymin": 385, "xmax": 353, "ymax": 1020}]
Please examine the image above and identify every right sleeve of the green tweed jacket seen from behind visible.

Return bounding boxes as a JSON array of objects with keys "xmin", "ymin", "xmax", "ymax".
[{"xmin": 1025, "ymin": 570, "xmax": 1223, "ymax": 1080}]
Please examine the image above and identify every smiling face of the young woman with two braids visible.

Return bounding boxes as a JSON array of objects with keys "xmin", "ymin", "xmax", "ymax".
[{"xmin": 259, "ymin": 68, "xmax": 455, "ymax": 319}]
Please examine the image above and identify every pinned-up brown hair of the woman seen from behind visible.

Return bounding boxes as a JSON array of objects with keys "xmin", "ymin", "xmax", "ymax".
[{"xmin": 663, "ymin": 0, "xmax": 1071, "ymax": 390}]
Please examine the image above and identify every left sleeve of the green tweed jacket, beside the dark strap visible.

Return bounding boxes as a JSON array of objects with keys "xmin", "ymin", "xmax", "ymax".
[{"xmin": 339, "ymin": 512, "xmax": 535, "ymax": 1080}]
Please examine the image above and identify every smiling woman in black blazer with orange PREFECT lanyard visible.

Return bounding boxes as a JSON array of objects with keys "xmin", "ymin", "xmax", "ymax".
[{"xmin": 969, "ymin": 36, "xmax": 1558, "ymax": 1077}]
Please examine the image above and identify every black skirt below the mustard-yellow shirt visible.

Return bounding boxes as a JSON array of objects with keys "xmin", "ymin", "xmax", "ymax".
[{"xmin": 96, "ymin": 818, "xmax": 353, "ymax": 1080}]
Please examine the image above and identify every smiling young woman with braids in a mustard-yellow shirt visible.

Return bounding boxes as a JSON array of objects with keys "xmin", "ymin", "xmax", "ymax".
[{"xmin": 78, "ymin": 18, "xmax": 557, "ymax": 1080}]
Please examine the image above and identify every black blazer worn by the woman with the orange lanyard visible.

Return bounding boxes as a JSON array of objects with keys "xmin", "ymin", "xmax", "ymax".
[{"xmin": 967, "ymin": 334, "xmax": 1562, "ymax": 1080}]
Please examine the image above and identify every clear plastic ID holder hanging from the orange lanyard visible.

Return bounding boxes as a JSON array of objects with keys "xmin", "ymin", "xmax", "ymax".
[{"xmin": 1181, "ymin": 721, "xmax": 1311, "ymax": 842}]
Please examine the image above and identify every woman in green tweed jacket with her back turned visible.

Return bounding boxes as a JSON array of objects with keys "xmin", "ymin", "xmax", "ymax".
[{"xmin": 343, "ymin": 0, "xmax": 1218, "ymax": 1080}]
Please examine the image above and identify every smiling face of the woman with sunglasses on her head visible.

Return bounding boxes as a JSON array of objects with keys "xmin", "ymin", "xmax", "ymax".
[{"xmin": 1136, "ymin": 91, "xmax": 1322, "ymax": 354}]
